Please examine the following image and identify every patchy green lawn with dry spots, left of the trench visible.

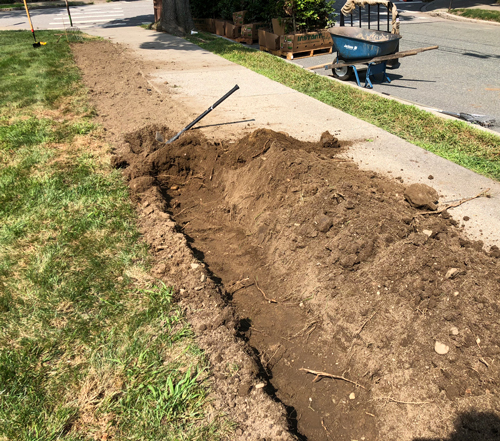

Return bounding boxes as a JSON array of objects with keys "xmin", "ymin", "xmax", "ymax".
[{"xmin": 0, "ymin": 31, "xmax": 229, "ymax": 441}]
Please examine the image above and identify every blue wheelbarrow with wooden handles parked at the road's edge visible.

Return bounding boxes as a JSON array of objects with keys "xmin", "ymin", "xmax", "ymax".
[{"xmin": 309, "ymin": 27, "xmax": 438, "ymax": 89}]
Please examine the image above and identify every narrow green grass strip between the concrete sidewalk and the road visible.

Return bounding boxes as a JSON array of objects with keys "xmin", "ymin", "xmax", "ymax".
[{"xmin": 187, "ymin": 32, "xmax": 500, "ymax": 180}]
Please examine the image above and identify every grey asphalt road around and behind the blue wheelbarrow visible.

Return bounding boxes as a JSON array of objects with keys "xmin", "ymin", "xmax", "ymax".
[{"xmin": 293, "ymin": 2, "xmax": 500, "ymax": 132}]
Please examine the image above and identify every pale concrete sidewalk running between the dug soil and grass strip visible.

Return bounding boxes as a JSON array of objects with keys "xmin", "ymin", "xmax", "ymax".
[{"xmin": 84, "ymin": 27, "xmax": 500, "ymax": 246}]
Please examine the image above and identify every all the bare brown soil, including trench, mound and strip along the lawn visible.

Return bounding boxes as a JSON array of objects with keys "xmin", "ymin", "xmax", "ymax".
[{"xmin": 76, "ymin": 42, "xmax": 500, "ymax": 441}]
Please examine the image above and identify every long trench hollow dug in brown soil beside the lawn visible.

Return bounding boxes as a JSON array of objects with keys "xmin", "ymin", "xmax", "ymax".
[{"xmin": 131, "ymin": 128, "xmax": 375, "ymax": 441}]
